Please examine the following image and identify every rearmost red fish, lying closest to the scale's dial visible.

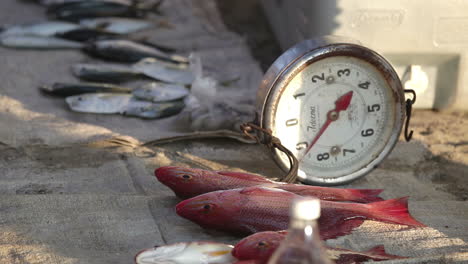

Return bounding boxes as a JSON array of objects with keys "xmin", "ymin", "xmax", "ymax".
[{"xmin": 154, "ymin": 167, "xmax": 383, "ymax": 203}]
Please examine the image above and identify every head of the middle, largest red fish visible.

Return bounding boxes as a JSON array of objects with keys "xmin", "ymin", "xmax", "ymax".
[{"xmin": 176, "ymin": 190, "xmax": 241, "ymax": 230}]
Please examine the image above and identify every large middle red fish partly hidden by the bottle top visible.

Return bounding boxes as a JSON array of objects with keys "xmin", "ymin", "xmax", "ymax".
[{"xmin": 176, "ymin": 187, "xmax": 425, "ymax": 240}]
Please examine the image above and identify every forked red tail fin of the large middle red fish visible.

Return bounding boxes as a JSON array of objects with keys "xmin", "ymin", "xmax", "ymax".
[{"xmin": 366, "ymin": 197, "xmax": 426, "ymax": 227}]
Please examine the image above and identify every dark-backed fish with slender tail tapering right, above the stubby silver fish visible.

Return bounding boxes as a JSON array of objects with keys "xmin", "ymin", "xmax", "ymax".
[{"xmin": 85, "ymin": 40, "xmax": 188, "ymax": 63}]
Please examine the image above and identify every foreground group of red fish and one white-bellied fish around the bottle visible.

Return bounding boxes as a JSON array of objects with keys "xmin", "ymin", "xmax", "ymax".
[{"xmin": 136, "ymin": 167, "xmax": 425, "ymax": 264}]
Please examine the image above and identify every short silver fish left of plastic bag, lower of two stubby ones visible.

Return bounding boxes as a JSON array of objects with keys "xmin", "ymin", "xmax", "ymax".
[{"xmin": 132, "ymin": 82, "xmax": 190, "ymax": 102}]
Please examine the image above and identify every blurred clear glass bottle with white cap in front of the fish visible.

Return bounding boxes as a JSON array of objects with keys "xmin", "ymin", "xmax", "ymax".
[{"xmin": 268, "ymin": 197, "xmax": 333, "ymax": 264}]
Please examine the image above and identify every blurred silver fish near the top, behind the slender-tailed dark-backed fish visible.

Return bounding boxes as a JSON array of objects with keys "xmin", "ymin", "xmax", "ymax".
[{"xmin": 80, "ymin": 17, "xmax": 153, "ymax": 34}]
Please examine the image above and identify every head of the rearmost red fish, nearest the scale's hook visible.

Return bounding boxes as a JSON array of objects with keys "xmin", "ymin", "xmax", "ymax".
[{"xmin": 154, "ymin": 166, "xmax": 207, "ymax": 198}]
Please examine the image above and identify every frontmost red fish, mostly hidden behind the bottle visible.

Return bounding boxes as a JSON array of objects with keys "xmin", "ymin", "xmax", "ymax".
[{"xmin": 232, "ymin": 231, "xmax": 405, "ymax": 264}]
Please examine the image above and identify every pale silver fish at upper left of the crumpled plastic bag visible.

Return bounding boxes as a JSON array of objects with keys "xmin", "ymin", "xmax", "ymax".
[{"xmin": 133, "ymin": 58, "xmax": 195, "ymax": 85}]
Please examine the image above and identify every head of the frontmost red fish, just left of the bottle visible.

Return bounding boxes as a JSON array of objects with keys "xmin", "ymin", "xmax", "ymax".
[{"xmin": 232, "ymin": 231, "xmax": 286, "ymax": 263}]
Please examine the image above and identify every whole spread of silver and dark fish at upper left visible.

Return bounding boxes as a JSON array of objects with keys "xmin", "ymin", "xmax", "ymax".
[{"xmin": 0, "ymin": 0, "xmax": 194, "ymax": 119}]
